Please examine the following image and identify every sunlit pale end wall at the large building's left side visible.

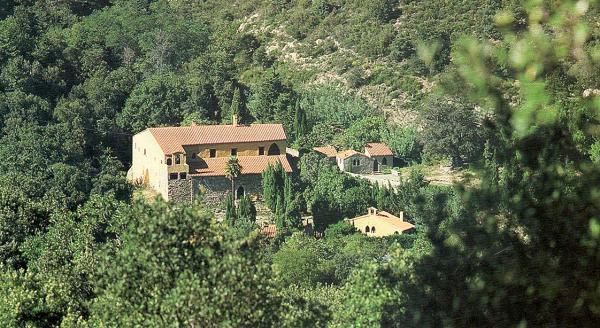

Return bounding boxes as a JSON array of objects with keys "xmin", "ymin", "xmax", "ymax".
[{"xmin": 127, "ymin": 130, "xmax": 169, "ymax": 199}]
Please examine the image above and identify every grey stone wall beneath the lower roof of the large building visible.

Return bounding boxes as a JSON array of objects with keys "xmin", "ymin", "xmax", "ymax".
[{"xmin": 193, "ymin": 174, "xmax": 262, "ymax": 205}]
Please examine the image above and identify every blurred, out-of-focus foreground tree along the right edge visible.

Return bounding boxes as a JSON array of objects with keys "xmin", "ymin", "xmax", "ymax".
[{"xmin": 387, "ymin": 1, "xmax": 600, "ymax": 327}]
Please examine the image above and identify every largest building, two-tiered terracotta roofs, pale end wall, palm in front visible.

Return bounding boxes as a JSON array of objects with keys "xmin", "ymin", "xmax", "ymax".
[{"xmin": 127, "ymin": 119, "xmax": 292, "ymax": 203}]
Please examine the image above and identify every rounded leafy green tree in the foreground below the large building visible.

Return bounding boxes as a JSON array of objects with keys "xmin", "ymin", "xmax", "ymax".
[{"xmin": 90, "ymin": 201, "xmax": 292, "ymax": 327}]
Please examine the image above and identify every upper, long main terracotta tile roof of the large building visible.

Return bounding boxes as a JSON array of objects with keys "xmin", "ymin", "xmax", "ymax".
[{"xmin": 148, "ymin": 124, "xmax": 287, "ymax": 155}]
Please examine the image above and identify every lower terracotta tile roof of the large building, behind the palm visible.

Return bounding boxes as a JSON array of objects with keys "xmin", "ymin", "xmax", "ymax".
[{"xmin": 188, "ymin": 155, "xmax": 292, "ymax": 177}]
